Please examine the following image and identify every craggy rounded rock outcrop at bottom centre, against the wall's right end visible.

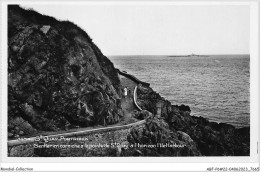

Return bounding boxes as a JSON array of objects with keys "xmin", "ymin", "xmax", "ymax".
[{"xmin": 124, "ymin": 116, "xmax": 201, "ymax": 157}]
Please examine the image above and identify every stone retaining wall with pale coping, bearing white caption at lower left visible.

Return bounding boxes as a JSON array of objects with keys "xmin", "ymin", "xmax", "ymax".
[{"xmin": 8, "ymin": 120, "xmax": 145, "ymax": 157}]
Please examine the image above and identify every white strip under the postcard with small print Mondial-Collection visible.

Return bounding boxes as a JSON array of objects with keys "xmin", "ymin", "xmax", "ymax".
[{"xmin": 0, "ymin": 163, "xmax": 259, "ymax": 172}]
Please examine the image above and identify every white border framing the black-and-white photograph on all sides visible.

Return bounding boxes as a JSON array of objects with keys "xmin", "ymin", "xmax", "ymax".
[{"xmin": 0, "ymin": 1, "xmax": 259, "ymax": 170}]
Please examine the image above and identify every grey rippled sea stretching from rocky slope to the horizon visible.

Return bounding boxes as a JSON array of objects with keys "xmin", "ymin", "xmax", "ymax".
[{"xmin": 109, "ymin": 55, "xmax": 250, "ymax": 127}]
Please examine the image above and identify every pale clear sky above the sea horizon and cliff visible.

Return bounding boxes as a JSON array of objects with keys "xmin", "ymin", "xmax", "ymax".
[{"xmin": 21, "ymin": 4, "xmax": 250, "ymax": 56}]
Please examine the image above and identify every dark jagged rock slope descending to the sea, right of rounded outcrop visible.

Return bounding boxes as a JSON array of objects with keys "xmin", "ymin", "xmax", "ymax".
[{"xmin": 134, "ymin": 86, "xmax": 250, "ymax": 156}]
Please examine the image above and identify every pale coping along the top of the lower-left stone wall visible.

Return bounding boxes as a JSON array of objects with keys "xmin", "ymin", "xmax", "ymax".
[{"xmin": 7, "ymin": 119, "xmax": 145, "ymax": 147}]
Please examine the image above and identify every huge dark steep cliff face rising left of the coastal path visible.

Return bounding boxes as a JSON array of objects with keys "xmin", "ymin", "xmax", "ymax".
[{"xmin": 8, "ymin": 5, "xmax": 123, "ymax": 138}]
